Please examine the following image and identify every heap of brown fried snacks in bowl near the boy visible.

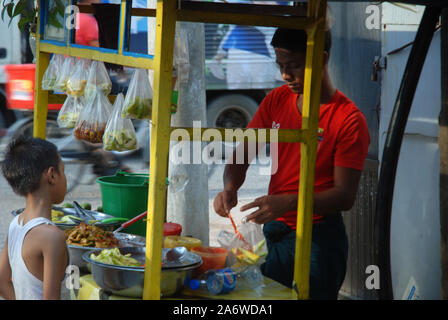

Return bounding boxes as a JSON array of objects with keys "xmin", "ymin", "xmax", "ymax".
[{"xmin": 65, "ymin": 222, "xmax": 118, "ymax": 248}]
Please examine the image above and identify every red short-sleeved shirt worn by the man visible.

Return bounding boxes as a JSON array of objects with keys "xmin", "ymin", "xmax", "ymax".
[{"xmin": 248, "ymin": 85, "xmax": 370, "ymax": 229}]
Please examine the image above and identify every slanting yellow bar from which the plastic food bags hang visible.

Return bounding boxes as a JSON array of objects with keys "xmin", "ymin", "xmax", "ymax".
[{"xmin": 40, "ymin": 42, "xmax": 153, "ymax": 69}]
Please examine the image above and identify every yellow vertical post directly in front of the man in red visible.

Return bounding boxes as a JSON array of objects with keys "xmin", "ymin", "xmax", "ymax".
[{"xmin": 293, "ymin": 0, "xmax": 326, "ymax": 299}]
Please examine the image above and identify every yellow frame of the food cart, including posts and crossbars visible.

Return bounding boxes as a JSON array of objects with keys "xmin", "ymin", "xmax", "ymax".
[{"xmin": 34, "ymin": 0, "xmax": 327, "ymax": 300}]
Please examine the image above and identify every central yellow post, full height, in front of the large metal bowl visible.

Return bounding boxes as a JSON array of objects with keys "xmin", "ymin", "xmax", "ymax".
[{"xmin": 143, "ymin": 0, "xmax": 176, "ymax": 300}]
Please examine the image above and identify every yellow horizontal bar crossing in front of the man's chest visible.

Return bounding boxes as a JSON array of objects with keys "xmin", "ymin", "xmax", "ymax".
[{"xmin": 170, "ymin": 127, "xmax": 308, "ymax": 142}]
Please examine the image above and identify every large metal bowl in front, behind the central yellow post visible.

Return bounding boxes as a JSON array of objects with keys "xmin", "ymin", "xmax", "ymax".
[{"xmin": 83, "ymin": 247, "xmax": 202, "ymax": 298}]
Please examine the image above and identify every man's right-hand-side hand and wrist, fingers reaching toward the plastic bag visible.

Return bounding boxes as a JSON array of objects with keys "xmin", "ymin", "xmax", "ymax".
[{"xmin": 241, "ymin": 194, "xmax": 297, "ymax": 224}]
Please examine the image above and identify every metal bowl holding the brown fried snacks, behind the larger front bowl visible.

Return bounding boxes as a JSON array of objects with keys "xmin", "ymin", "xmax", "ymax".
[{"xmin": 67, "ymin": 232, "xmax": 146, "ymax": 273}]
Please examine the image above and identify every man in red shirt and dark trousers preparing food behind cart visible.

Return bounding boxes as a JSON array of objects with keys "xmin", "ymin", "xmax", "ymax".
[{"xmin": 214, "ymin": 29, "xmax": 370, "ymax": 299}]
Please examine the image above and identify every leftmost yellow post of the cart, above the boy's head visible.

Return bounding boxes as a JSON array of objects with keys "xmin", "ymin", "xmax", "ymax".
[{"xmin": 33, "ymin": 3, "xmax": 50, "ymax": 139}]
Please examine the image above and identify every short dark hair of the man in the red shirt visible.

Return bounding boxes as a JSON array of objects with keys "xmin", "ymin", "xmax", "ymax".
[{"xmin": 271, "ymin": 28, "xmax": 331, "ymax": 55}]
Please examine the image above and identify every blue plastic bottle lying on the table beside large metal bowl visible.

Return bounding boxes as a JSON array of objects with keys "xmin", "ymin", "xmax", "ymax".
[{"xmin": 189, "ymin": 268, "xmax": 236, "ymax": 295}]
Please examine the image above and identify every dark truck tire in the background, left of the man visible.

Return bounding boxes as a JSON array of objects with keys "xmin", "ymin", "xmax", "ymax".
[{"xmin": 207, "ymin": 94, "xmax": 258, "ymax": 128}]
